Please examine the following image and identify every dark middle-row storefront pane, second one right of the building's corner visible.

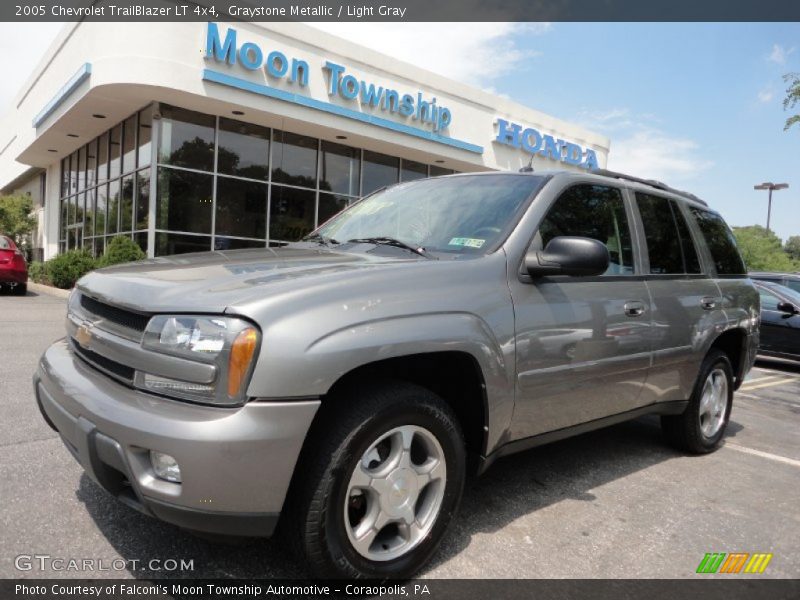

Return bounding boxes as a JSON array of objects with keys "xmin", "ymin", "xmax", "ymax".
[{"xmin": 215, "ymin": 176, "xmax": 268, "ymax": 239}]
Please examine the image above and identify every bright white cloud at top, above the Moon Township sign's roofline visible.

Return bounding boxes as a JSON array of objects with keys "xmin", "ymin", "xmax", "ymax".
[{"xmin": 308, "ymin": 22, "xmax": 552, "ymax": 89}]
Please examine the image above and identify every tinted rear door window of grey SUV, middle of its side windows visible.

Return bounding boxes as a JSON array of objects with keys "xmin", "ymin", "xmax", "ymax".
[{"xmin": 636, "ymin": 192, "xmax": 700, "ymax": 275}]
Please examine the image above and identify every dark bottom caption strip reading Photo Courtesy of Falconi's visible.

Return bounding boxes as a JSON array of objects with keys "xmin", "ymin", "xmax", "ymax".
[{"xmin": 0, "ymin": 579, "xmax": 800, "ymax": 600}]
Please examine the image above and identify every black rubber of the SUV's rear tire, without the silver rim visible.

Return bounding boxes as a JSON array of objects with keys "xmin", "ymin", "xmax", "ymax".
[{"xmin": 661, "ymin": 350, "xmax": 733, "ymax": 454}]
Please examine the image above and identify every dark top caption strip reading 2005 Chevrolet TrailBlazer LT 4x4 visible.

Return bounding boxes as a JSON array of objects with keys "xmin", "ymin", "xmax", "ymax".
[{"xmin": 0, "ymin": 0, "xmax": 800, "ymax": 22}]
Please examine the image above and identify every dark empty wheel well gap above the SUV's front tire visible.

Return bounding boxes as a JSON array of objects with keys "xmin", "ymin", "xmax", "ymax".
[{"xmin": 322, "ymin": 352, "xmax": 487, "ymax": 459}]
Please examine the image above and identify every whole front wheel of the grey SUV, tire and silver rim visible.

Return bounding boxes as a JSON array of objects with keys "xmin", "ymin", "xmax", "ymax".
[{"xmin": 285, "ymin": 382, "xmax": 466, "ymax": 578}]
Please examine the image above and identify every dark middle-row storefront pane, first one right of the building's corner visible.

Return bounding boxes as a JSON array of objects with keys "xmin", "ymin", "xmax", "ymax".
[{"xmin": 156, "ymin": 167, "xmax": 214, "ymax": 234}]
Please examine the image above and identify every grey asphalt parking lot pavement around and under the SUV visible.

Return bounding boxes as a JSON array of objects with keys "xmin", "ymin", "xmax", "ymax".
[{"xmin": 0, "ymin": 292, "xmax": 800, "ymax": 578}]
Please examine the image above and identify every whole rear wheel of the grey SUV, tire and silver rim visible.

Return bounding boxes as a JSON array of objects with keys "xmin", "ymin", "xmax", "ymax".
[{"xmin": 661, "ymin": 350, "xmax": 733, "ymax": 454}]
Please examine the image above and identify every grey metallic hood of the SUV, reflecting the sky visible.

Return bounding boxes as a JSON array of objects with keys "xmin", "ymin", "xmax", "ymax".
[{"xmin": 76, "ymin": 247, "xmax": 422, "ymax": 313}]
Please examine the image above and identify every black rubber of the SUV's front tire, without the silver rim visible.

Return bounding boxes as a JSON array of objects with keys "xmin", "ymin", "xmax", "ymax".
[{"xmin": 281, "ymin": 382, "xmax": 466, "ymax": 579}]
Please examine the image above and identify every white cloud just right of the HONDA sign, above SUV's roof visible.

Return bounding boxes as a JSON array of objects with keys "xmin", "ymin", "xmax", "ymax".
[{"xmin": 576, "ymin": 108, "xmax": 714, "ymax": 185}]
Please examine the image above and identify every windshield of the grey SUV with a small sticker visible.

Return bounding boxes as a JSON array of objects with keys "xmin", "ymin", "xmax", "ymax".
[{"xmin": 316, "ymin": 174, "xmax": 546, "ymax": 254}]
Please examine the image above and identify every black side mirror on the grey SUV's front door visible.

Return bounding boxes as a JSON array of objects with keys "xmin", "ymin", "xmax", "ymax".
[{"xmin": 525, "ymin": 236, "xmax": 609, "ymax": 277}]
